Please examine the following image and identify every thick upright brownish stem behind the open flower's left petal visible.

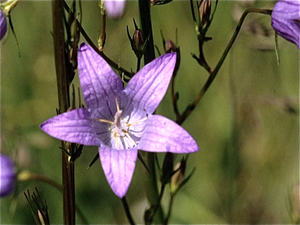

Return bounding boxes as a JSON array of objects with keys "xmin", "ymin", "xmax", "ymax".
[{"xmin": 52, "ymin": 0, "xmax": 75, "ymax": 224}]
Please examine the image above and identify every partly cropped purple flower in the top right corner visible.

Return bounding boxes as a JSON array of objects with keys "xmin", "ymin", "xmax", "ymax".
[{"xmin": 271, "ymin": 0, "xmax": 300, "ymax": 48}]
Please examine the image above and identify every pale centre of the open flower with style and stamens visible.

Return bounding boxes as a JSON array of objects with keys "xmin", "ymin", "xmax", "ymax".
[{"xmin": 97, "ymin": 97, "xmax": 147, "ymax": 149}]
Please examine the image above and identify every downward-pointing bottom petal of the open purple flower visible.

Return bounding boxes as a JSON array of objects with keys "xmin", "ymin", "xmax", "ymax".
[{"xmin": 99, "ymin": 146, "xmax": 138, "ymax": 198}]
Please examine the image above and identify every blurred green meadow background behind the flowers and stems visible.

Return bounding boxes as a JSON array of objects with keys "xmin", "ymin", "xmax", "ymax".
[{"xmin": 1, "ymin": 1, "xmax": 299, "ymax": 224}]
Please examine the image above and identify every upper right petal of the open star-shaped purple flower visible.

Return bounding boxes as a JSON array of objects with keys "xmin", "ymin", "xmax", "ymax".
[{"xmin": 124, "ymin": 53, "xmax": 176, "ymax": 114}]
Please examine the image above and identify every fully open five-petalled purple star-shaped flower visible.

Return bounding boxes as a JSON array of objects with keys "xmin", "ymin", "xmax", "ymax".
[{"xmin": 41, "ymin": 43, "xmax": 199, "ymax": 198}]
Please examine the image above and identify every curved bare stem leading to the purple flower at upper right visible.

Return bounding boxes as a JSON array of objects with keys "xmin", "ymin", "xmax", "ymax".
[{"xmin": 176, "ymin": 9, "xmax": 272, "ymax": 125}]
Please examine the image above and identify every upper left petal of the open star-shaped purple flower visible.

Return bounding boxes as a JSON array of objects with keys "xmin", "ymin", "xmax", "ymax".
[{"xmin": 78, "ymin": 43, "xmax": 123, "ymax": 111}]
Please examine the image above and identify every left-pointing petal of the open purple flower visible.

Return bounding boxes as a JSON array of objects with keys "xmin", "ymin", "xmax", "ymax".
[{"xmin": 40, "ymin": 108, "xmax": 100, "ymax": 146}]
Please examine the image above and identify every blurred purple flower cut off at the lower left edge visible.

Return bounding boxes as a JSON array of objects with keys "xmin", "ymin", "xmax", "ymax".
[{"xmin": 0, "ymin": 154, "xmax": 16, "ymax": 197}]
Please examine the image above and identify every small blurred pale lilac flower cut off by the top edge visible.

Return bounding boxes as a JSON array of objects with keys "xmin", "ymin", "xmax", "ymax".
[{"xmin": 104, "ymin": 0, "xmax": 126, "ymax": 19}]
